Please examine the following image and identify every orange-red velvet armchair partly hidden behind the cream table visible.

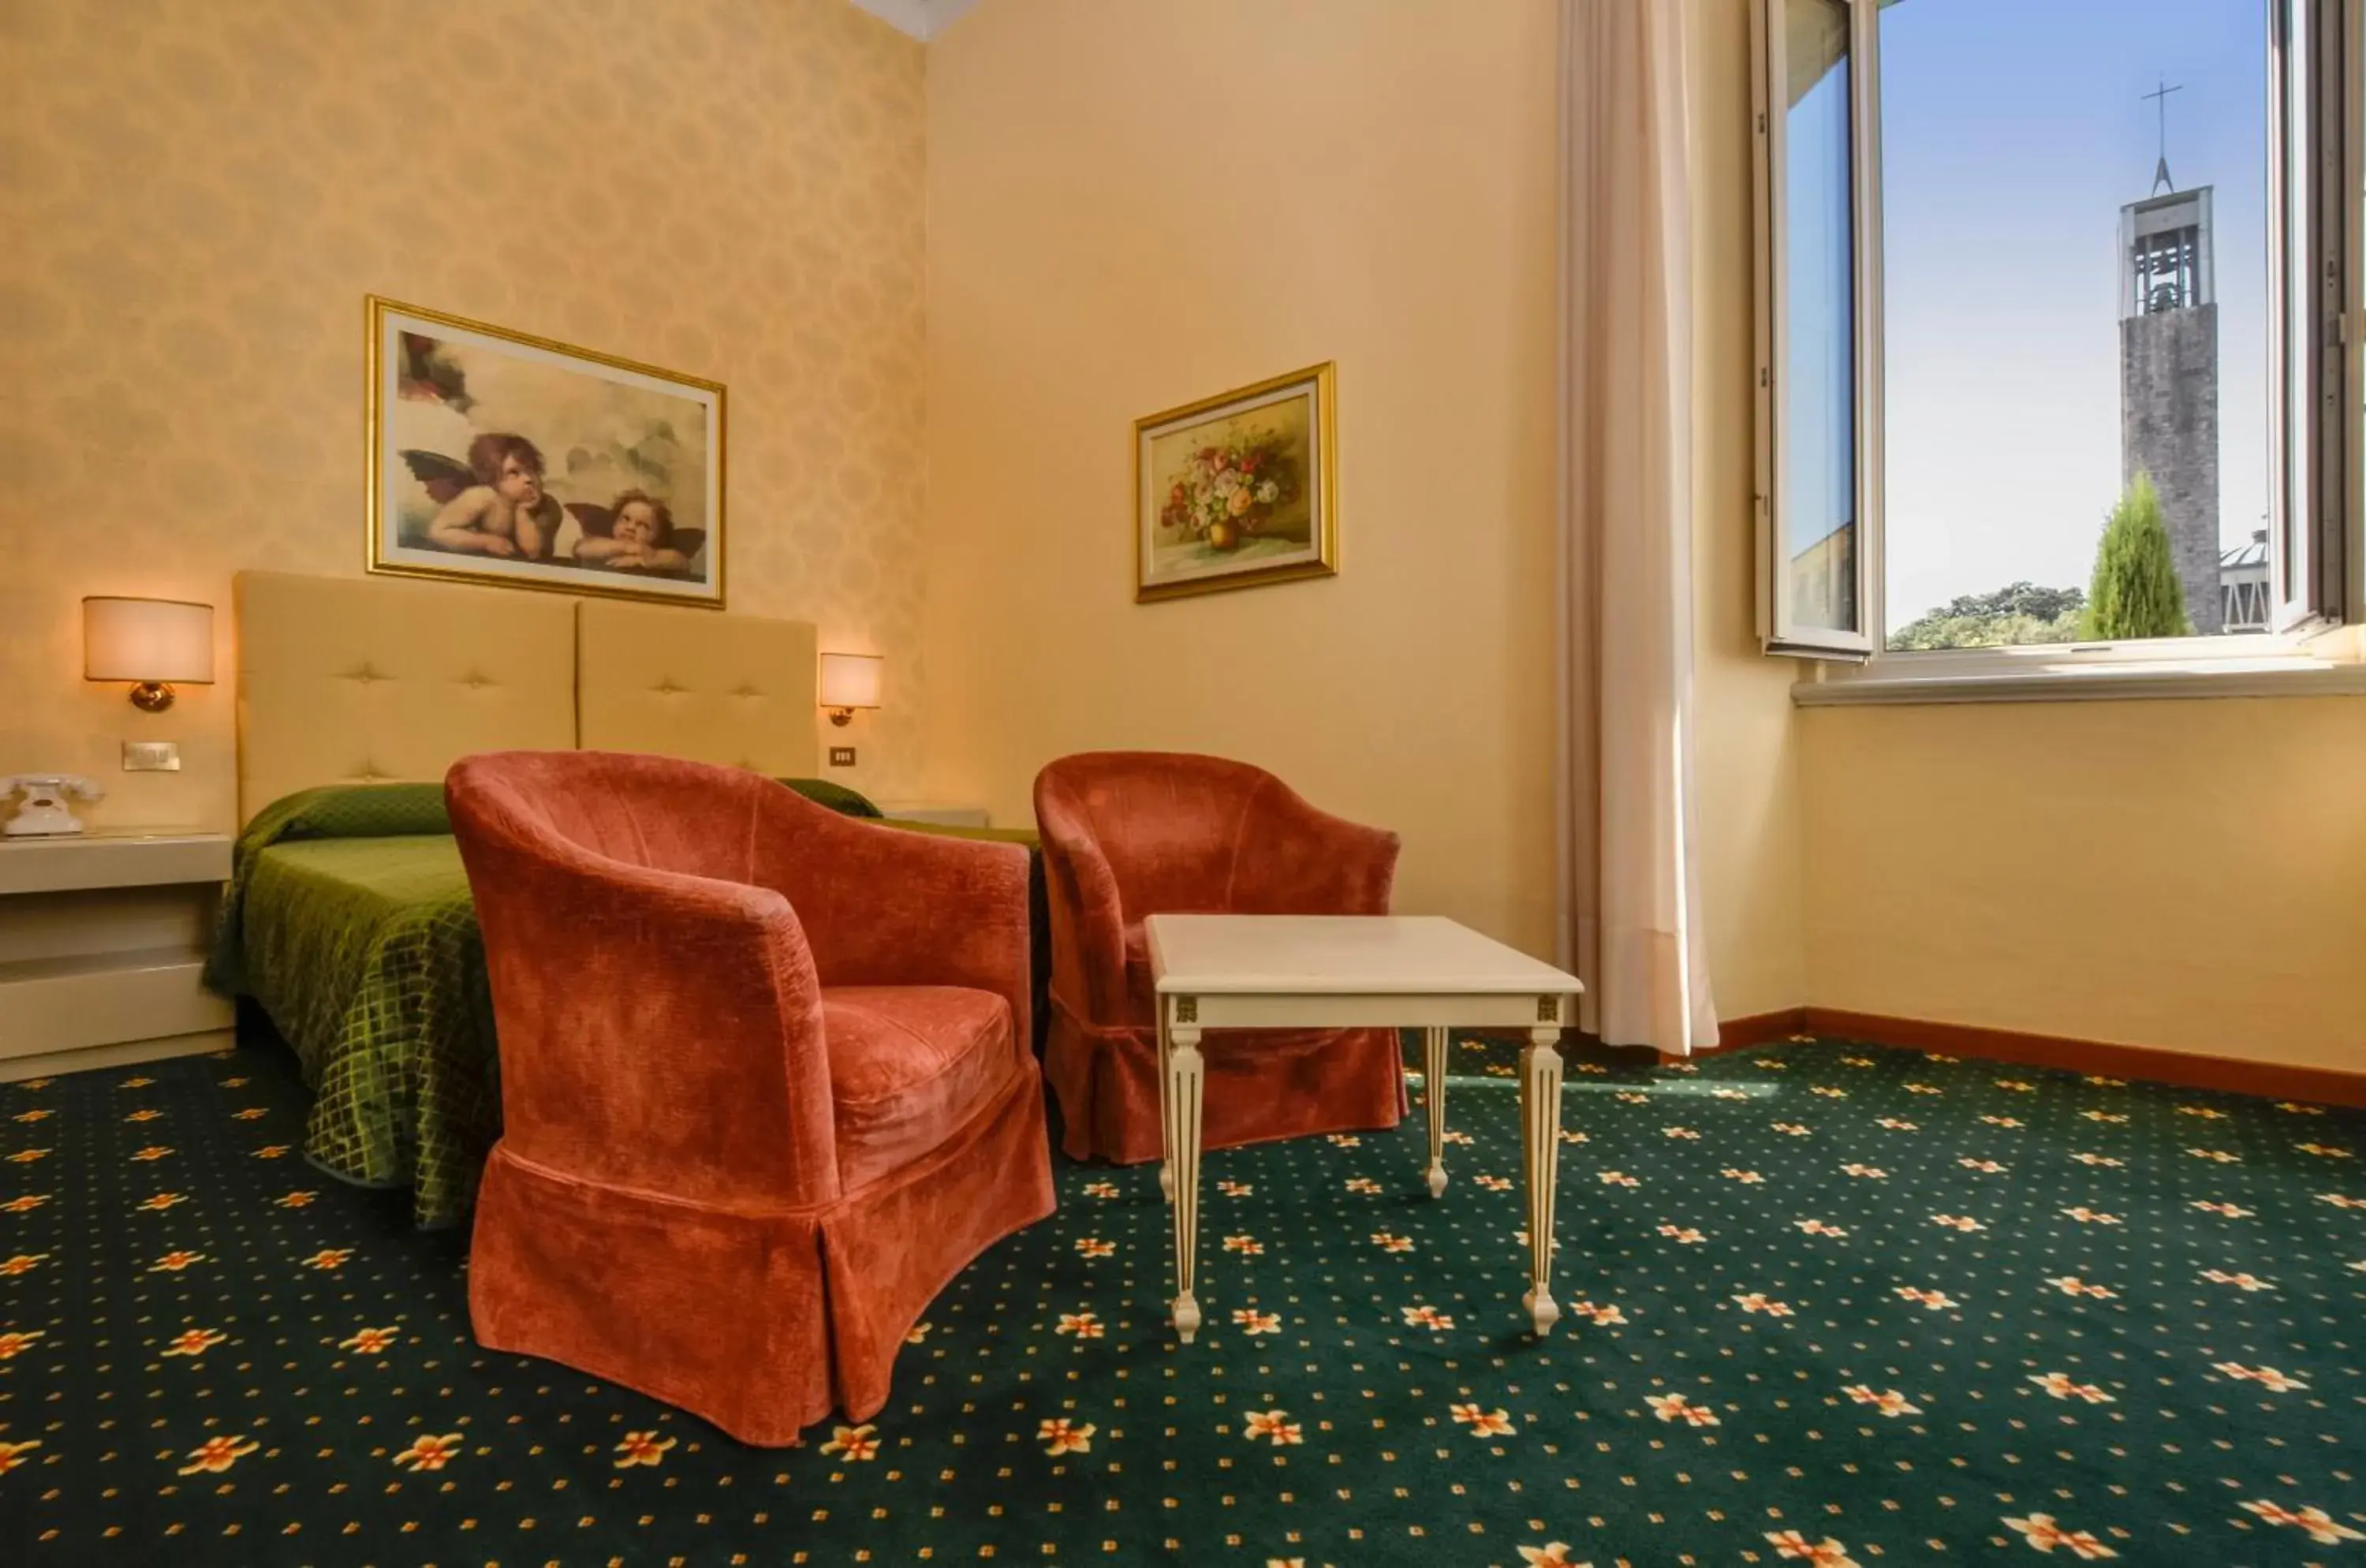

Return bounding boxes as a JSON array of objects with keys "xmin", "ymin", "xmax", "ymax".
[{"xmin": 1034, "ymin": 752, "xmax": 1405, "ymax": 1163}]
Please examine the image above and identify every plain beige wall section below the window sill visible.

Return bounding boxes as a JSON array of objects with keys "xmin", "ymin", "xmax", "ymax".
[{"xmin": 1805, "ymin": 698, "xmax": 2366, "ymax": 1071}]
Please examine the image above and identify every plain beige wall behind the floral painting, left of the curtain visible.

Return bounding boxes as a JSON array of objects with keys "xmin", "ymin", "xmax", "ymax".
[{"xmin": 927, "ymin": 0, "xmax": 1554, "ymax": 950}]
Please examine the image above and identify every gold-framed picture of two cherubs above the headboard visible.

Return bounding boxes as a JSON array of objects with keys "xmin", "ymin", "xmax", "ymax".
[{"xmin": 369, "ymin": 296, "xmax": 726, "ymax": 608}]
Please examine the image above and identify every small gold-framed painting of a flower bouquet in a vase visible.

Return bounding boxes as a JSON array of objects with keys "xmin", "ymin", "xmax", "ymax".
[{"xmin": 1133, "ymin": 364, "xmax": 1339, "ymax": 601}]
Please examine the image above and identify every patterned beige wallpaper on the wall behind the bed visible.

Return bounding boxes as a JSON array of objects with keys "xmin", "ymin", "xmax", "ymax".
[{"xmin": 0, "ymin": 0, "xmax": 925, "ymax": 825}]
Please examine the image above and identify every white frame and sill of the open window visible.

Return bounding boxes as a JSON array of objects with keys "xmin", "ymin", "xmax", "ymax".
[{"xmin": 1751, "ymin": 0, "xmax": 2366, "ymax": 703}]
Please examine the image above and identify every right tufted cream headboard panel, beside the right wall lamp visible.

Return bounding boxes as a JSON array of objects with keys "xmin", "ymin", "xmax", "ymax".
[{"xmin": 575, "ymin": 599, "xmax": 821, "ymax": 778}]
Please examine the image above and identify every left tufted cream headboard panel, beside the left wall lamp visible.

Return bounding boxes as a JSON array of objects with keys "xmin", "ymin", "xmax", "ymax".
[{"xmin": 234, "ymin": 573, "xmax": 582, "ymax": 823}]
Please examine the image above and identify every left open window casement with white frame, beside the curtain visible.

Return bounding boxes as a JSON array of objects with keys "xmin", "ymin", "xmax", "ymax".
[{"xmin": 1751, "ymin": 0, "xmax": 1881, "ymax": 658}]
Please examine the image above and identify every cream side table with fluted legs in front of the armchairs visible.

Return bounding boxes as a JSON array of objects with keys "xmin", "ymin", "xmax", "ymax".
[{"xmin": 1143, "ymin": 915, "xmax": 1585, "ymax": 1346}]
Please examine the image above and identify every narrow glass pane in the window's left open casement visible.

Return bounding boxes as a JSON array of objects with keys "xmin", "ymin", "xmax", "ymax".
[{"xmin": 1779, "ymin": 0, "xmax": 1860, "ymax": 632}]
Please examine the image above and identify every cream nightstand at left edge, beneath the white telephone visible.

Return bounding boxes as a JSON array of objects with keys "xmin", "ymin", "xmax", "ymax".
[{"xmin": 0, "ymin": 827, "xmax": 234, "ymax": 1081}]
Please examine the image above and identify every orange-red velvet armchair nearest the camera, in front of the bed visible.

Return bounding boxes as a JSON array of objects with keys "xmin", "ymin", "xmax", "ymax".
[{"xmin": 445, "ymin": 752, "xmax": 1053, "ymax": 1445}]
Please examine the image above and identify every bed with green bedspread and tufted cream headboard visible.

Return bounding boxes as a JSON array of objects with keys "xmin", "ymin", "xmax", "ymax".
[{"xmin": 206, "ymin": 573, "xmax": 1048, "ymax": 1227}]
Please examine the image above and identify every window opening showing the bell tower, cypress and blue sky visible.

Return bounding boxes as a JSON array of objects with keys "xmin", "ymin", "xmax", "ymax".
[{"xmin": 1881, "ymin": 0, "xmax": 2276, "ymax": 648}]
